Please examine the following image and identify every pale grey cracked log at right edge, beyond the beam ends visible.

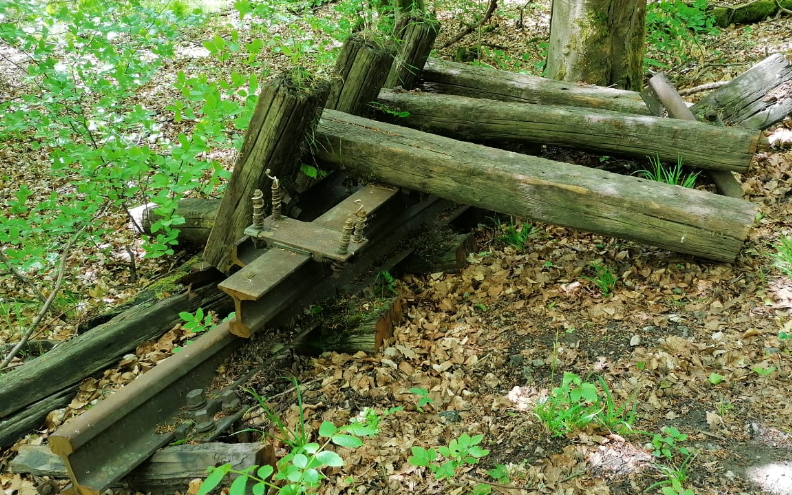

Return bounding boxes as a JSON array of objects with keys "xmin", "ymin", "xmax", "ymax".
[{"xmin": 691, "ymin": 53, "xmax": 792, "ymax": 129}]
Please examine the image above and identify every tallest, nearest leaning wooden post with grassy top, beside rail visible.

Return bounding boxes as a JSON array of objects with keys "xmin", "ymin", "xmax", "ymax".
[{"xmin": 204, "ymin": 72, "xmax": 329, "ymax": 272}]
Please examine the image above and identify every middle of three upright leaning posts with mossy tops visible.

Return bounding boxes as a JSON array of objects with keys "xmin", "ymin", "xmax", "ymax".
[{"xmin": 325, "ymin": 31, "xmax": 394, "ymax": 115}]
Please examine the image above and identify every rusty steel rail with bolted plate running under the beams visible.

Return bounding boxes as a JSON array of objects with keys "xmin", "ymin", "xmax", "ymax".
[{"xmin": 50, "ymin": 181, "xmax": 450, "ymax": 495}]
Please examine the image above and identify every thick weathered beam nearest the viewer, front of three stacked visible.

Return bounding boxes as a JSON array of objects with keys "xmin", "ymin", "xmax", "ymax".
[{"xmin": 315, "ymin": 110, "xmax": 757, "ymax": 262}]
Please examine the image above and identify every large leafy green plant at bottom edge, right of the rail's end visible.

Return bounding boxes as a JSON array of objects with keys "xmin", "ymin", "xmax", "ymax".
[{"xmin": 197, "ymin": 378, "xmax": 384, "ymax": 495}]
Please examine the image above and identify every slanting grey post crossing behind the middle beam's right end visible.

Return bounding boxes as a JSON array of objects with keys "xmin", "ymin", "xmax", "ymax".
[{"xmin": 645, "ymin": 73, "xmax": 756, "ymax": 198}]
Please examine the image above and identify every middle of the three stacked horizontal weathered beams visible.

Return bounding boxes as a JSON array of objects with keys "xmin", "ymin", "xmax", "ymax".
[{"xmin": 378, "ymin": 90, "xmax": 761, "ymax": 171}]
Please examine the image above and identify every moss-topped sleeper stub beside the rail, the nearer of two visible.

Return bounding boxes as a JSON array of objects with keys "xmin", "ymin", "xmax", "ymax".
[{"xmin": 297, "ymin": 296, "xmax": 404, "ymax": 354}]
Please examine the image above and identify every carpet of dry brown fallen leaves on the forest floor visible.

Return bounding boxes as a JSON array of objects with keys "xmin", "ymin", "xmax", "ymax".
[{"xmin": 0, "ymin": 3, "xmax": 792, "ymax": 495}]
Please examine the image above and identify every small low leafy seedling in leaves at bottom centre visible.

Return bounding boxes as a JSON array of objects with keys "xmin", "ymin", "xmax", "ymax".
[{"xmin": 407, "ymin": 433, "xmax": 489, "ymax": 494}]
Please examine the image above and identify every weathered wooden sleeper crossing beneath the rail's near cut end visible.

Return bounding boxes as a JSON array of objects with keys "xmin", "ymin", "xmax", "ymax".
[{"xmin": 9, "ymin": 442, "xmax": 271, "ymax": 494}]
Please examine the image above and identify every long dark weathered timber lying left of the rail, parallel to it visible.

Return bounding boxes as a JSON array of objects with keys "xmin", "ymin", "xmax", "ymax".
[{"xmin": 0, "ymin": 285, "xmax": 234, "ymax": 430}]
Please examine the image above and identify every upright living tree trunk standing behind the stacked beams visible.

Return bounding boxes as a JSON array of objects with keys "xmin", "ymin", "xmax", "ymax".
[{"xmin": 546, "ymin": 0, "xmax": 646, "ymax": 91}]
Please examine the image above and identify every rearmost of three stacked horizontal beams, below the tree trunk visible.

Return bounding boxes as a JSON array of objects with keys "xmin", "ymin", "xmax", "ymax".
[{"xmin": 421, "ymin": 58, "xmax": 650, "ymax": 115}]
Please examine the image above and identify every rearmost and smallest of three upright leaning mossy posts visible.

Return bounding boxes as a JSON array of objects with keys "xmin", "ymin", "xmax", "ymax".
[{"xmin": 384, "ymin": 14, "xmax": 440, "ymax": 89}]
